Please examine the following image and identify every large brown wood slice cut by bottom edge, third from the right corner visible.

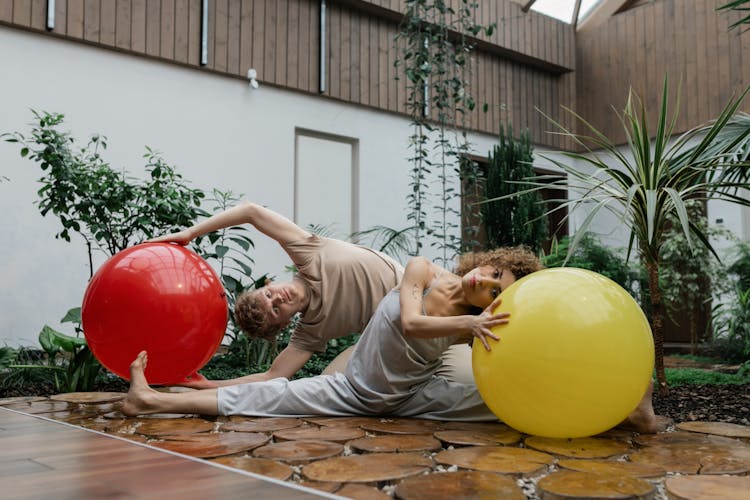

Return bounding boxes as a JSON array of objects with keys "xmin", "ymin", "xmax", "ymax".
[{"xmin": 396, "ymin": 471, "xmax": 526, "ymax": 500}]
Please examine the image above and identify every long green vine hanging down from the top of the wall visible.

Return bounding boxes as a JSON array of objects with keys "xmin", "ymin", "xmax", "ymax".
[{"xmin": 396, "ymin": 0, "xmax": 494, "ymax": 265}]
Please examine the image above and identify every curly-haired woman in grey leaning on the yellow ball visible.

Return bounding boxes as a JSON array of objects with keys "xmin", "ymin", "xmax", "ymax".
[{"xmin": 123, "ymin": 248, "xmax": 653, "ymax": 430}]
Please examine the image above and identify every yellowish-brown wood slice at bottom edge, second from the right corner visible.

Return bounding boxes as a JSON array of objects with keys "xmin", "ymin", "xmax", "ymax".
[{"xmin": 536, "ymin": 471, "xmax": 656, "ymax": 500}]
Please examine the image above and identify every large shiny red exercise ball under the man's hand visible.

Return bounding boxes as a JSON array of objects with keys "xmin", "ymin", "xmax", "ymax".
[{"xmin": 81, "ymin": 243, "xmax": 227, "ymax": 385}]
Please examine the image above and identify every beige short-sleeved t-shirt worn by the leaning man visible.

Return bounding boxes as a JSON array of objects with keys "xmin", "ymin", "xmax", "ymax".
[{"xmin": 284, "ymin": 235, "xmax": 404, "ymax": 352}]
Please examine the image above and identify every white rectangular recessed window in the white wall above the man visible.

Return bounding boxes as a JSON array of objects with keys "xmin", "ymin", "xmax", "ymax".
[{"xmin": 294, "ymin": 129, "xmax": 358, "ymax": 239}]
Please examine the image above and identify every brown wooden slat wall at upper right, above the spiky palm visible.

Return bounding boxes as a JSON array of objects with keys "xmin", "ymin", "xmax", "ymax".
[{"xmin": 576, "ymin": 0, "xmax": 750, "ymax": 143}]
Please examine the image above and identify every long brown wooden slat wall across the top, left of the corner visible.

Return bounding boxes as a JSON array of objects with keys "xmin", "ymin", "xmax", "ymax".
[{"xmin": 0, "ymin": 0, "xmax": 576, "ymax": 147}]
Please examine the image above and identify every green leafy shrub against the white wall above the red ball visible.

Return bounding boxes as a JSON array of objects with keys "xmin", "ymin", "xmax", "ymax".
[{"xmin": 0, "ymin": 111, "xmax": 206, "ymax": 275}]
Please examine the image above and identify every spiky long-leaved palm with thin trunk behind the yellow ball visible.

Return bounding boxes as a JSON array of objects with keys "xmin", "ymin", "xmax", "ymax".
[{"xmin": 500, "ymin": 78, "xmax": 750, "ymax": 395}]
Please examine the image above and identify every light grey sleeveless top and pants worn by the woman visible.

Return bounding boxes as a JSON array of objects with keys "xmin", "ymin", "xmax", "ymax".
[{"xmin": 218, "ymin": 291, "xmax": 497, "ymax": 421}]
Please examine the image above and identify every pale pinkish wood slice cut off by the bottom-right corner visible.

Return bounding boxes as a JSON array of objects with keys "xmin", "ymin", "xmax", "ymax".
[{"xmin": 664, "ymin": 476, "xmax": 750, "ymax": 500}]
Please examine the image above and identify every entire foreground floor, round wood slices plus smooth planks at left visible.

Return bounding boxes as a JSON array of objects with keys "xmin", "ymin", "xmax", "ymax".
[{"xmin": 0, "ymin": 393, "xmax": 750, "ymax": 500}]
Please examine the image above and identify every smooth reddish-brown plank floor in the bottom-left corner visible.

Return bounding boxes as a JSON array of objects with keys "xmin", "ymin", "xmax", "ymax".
[{"xmin": 0, "ymin": 408, "xmax": 327, "ymax": 500}]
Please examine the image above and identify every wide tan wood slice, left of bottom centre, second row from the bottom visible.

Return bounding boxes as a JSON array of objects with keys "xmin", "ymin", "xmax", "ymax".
[{"xmin": 302, "ymin": 453, "xmax": 432, "ymax": 483}]
